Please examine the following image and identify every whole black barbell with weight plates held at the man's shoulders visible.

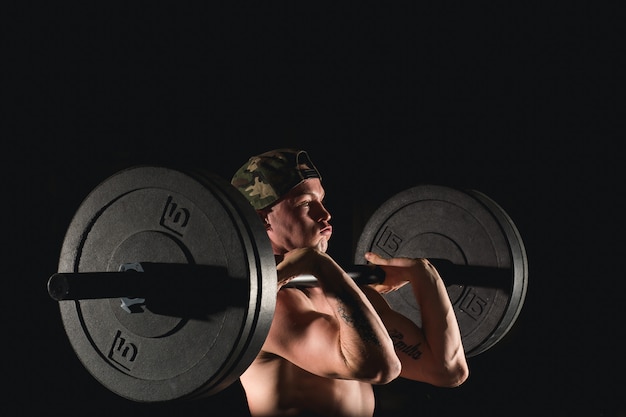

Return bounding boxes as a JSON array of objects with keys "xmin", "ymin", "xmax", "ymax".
[{"xmin": 47, "ymin": 166, "xmax": 528, "ymax": 402}]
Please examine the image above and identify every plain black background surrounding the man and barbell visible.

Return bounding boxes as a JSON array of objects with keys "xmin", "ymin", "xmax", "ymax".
[{"xmin": 2, "ymin": 2, "xmax": 626, "ymax": 416}]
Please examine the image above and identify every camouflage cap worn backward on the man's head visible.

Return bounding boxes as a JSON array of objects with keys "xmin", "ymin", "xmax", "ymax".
[{"xmin": 230, "ymin": 148, "xmax": 322, "ymax": 210}]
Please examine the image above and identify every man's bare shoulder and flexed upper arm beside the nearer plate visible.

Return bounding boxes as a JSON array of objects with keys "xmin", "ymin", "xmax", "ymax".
[{"xmin": 263, "ymin": 288, "xmax": 400, "ymax": 383}]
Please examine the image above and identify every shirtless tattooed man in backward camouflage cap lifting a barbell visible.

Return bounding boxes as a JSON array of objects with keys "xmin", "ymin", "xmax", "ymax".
[{"xmin": 231, "ymin": 149, "xmax": 469, "ymax": 417}]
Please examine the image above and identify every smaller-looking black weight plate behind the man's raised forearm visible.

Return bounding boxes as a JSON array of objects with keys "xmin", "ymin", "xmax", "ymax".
[{"xmin": 355, "ymin": 185, "xmax": 528, "ymax": 357}]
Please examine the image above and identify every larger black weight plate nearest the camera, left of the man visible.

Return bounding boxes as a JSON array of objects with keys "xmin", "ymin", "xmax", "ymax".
[{"xmin": 59, "ymin": 166, "xmax": 276, "ymax": 402}]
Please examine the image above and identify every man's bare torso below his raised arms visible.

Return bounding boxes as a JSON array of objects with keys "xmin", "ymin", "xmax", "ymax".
[{"xmin": 240, "ymin": 352, "xmax": 374, "ymax": 417}]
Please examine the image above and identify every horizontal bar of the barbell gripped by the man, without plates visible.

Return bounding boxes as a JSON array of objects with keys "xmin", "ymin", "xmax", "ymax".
[{"xmin": 48, "ymin": 258, "xmax": 511, "ymax": 302}]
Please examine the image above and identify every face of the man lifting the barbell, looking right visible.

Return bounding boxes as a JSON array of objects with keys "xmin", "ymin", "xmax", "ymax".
[{"xmin": 267, "ymin": 178, "xmax": 333, "ymax": 255}]
